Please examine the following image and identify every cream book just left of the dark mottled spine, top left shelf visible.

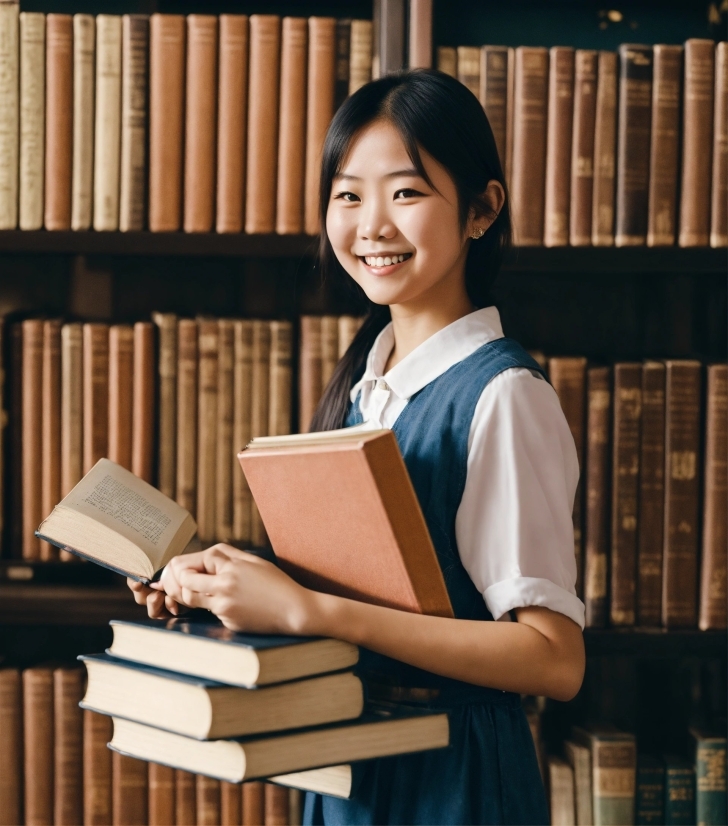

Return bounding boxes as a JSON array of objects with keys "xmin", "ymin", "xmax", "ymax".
[{"xmin": 93, "ymin": 14, "xmax": 121, "ymax": 231}]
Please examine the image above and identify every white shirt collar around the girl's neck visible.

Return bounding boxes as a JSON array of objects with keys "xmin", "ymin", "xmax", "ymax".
[{"xmin": 350, "ymin": 307, "xmax": 503, "ymax": 401}]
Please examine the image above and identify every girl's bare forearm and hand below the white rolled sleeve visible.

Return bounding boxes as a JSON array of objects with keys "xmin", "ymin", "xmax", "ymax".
[{"xmin": 154, "ymin": 545, "xmax": 585, "ymax": 700}]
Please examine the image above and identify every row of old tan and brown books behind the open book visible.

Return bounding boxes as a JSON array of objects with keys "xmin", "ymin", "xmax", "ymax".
[{"xmin": 5, "ymin": 313, "xmax": 359, "ymax": 561}]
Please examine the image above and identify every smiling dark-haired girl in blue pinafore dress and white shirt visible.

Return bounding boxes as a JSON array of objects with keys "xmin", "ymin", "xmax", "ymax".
[{"xmin": 132, "ymin": 71, "xmax": 584, "ymax": 824}]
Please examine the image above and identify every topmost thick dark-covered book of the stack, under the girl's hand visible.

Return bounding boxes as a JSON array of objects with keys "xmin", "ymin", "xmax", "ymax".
[{"xmin": 109, "ymin": 619, "xmax": 359, "ymax": 688}]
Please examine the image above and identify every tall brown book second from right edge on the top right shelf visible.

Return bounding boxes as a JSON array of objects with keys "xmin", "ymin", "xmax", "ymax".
[{"xmin": 678, "ymin": 38, "xmax": 715, "ymax": 247}]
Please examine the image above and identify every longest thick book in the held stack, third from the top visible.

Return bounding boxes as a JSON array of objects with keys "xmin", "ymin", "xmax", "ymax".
[{"xmin": 109, "ymin": 708, "xmax": 449, "ymax": 783}]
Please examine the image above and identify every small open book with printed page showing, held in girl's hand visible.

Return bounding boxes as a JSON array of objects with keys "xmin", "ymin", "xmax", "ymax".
[{"xmin": 36, "ymin": 459, "xmax": 197, "ymax": 583}]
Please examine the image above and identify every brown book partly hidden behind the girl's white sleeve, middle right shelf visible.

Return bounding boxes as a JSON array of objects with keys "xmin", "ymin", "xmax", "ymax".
[{"xmin": 549, "ymin": 357, "xmax": 586, "ymax": 597}]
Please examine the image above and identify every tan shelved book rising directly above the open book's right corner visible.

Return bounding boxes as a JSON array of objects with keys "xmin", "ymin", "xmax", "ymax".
[{"xmin": 175, "ymin": 318, "xmax": 197, "ymax": 515}]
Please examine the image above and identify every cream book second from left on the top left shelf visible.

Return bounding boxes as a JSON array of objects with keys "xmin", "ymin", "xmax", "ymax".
[{"xmin": 18, "ymin": 12, "xmax": 45, "ymax": 229}]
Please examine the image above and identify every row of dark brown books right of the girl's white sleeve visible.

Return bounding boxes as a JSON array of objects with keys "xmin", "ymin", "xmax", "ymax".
[{"xmin": 548, "ymin": 357, "xmax": 728, "ymax": 630}]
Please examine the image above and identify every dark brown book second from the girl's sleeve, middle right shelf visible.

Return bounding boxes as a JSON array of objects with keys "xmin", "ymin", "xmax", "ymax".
[{"xmin": 584, "ymin": 367, "xmax": 612, "ymax": 628}]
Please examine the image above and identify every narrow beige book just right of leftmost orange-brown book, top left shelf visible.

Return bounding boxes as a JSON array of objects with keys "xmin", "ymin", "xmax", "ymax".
[{"xmin": 71, "ymin": 14, "xmax": 96, "ymax": 230}]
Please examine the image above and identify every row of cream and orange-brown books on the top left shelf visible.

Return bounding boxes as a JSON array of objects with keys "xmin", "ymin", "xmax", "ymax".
[{"xmin": 0, "ymin": 2, "xmax": 372, "ymax": 234}]
